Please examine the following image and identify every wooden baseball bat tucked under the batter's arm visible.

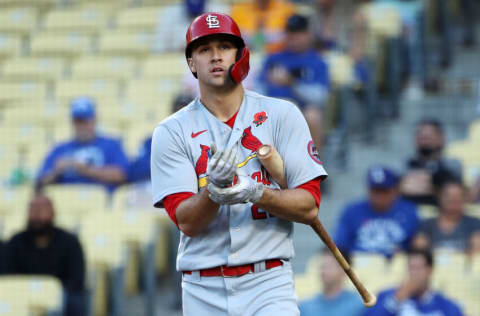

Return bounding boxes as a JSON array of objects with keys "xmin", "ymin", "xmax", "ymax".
[{"xmin": 257, "ymin": 145, "xmax": 377, "ymax": 307}]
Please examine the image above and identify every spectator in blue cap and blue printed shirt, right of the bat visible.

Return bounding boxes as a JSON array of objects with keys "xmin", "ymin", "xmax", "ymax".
[{"xmin": 335, "ymin": 166, "xmax": 419, "ymax": 257}]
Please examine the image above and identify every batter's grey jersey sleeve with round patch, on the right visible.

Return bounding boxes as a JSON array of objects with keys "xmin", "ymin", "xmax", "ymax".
[{"xmin": 274, "ymin": 106, "xmax": 327, "ymax": 188}]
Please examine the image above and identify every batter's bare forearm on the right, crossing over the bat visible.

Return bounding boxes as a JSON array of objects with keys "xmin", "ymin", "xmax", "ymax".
[{"xmin": 255, "ymin": 188, "xmax": 318, "ymax": 224}]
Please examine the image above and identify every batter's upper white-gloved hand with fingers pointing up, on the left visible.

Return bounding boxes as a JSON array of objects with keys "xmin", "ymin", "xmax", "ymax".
[{"xmin": 207, "ymin": 145, "xmax": 238, "ymax": 188}]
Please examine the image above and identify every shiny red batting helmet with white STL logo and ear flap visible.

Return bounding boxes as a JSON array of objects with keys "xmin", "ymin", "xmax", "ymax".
[{"xmin": 185, "ymin": 12, "xmax": 250, "ymax": 83}]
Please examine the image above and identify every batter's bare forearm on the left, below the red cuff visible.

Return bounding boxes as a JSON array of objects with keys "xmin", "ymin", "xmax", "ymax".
[{"xmin": 175, "ymin": 188, "xmax": 219, "ymax": 237}]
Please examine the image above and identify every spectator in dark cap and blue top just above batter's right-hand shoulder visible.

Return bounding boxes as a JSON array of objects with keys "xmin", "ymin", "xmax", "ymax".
[{"xmin": 259, "ymin": 15, "xmax": 329, "ymax": 152}]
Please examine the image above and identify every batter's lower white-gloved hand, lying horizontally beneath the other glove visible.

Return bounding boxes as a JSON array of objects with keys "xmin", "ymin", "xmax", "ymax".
[{"xmin": 207, "ymin": 175, "xmax": 264, "ymax": 205}]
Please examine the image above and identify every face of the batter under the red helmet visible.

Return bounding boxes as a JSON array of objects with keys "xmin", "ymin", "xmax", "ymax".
[{"xmin": 188, "ymin": 36, "xmax": 237, "ymax": 87}]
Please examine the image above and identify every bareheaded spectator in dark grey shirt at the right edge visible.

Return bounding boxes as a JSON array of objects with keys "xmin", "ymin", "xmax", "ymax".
[{"xmin": 414, "ymin": 182, "xmax": 480, "ymax": 253}]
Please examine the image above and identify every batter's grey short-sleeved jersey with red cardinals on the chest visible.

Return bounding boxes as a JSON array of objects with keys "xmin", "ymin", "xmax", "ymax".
[{"xmin": 151, "ymin": 90, "xmax": 327, "ymax": 271}]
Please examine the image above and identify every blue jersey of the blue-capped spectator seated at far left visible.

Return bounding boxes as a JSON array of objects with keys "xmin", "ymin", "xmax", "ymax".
[{"xmin": 38, "ymin": 136, "xmax": 128, "ymax": 190}]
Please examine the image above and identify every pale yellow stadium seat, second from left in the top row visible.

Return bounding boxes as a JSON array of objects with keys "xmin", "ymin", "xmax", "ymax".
[{"xmin": 45, "ymin": 8, "xmax": 108, "ymax": 34}]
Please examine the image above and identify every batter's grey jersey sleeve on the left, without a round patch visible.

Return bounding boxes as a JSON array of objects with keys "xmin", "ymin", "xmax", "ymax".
[{"xmin": 150, "ymin": 125, "xmax": 198, "ymax": 207}]
